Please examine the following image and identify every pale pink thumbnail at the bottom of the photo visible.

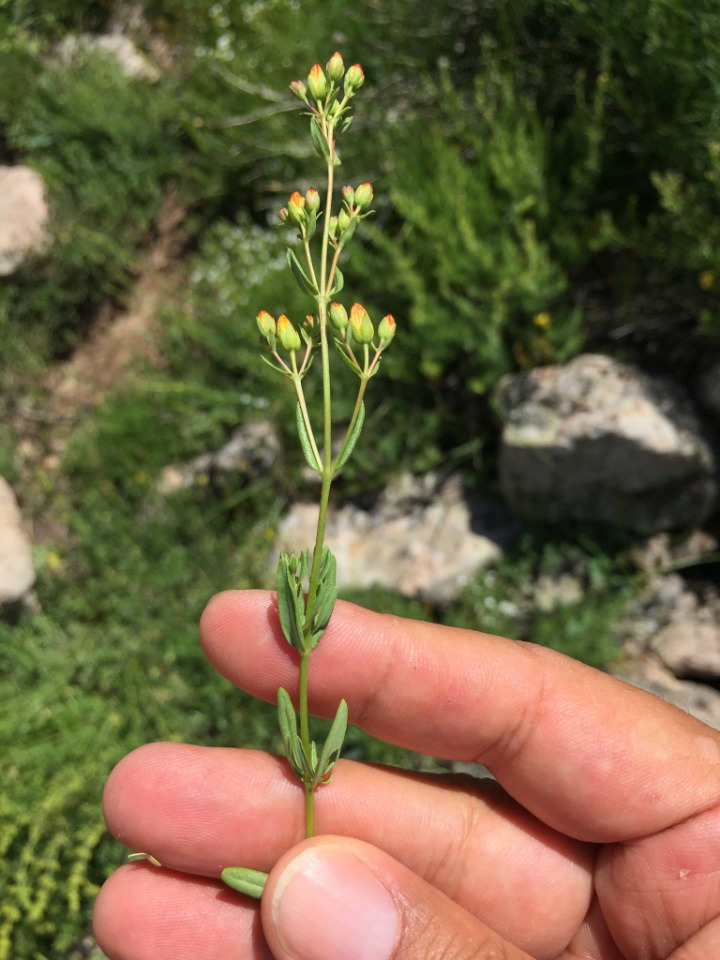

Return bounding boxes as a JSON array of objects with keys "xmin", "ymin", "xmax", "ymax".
[{"xmin": 272, "ymin": 846, "xmax": 400, "ymax": 960}]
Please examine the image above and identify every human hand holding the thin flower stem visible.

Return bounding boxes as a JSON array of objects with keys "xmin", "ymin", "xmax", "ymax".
[{"xmin": 95, "ymin": 591, "xmax": 720, "ymax": 960}]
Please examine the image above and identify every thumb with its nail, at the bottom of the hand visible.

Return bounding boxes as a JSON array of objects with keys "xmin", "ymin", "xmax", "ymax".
[{"xmin": 262, "ymin": 837, "xmax": 531, "ymax": 960}]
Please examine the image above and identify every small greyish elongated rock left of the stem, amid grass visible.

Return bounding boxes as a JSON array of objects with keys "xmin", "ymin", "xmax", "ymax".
[{"xmin": 157, "ymin": 420, "xmax": 280, "ymax": 496}]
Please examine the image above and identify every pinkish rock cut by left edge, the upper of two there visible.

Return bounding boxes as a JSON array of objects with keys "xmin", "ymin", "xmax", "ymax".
[{"xmin": 0, "ymin": 165, "xmax": 48, "ymax": 277}]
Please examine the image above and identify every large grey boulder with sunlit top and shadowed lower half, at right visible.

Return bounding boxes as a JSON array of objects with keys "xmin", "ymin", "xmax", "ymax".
[{"xmin": 497, "ymin": 355, "xmax": 717, "ymax": 533}]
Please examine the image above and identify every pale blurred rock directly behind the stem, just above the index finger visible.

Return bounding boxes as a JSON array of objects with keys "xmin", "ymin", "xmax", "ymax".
[{"xmin": 278, "ymin": 474, "xmax": 516, "ymax": 603}]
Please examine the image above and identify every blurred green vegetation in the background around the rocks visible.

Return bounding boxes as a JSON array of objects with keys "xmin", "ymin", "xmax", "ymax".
[{"xmin": 0, "ymin": 0, "xmax": 720, "ymax": 960}]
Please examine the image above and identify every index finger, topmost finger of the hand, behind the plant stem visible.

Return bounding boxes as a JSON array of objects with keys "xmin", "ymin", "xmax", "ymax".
[{"xmin": 200, "ymin": 591, "xmax": 720, "ymax": 842}]
